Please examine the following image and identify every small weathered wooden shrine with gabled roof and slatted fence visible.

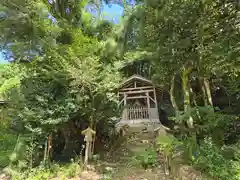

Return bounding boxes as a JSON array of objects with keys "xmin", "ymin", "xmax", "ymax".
[{"xmin": 118, "ymin": 75, "xmax": 160, "ymax": 125}]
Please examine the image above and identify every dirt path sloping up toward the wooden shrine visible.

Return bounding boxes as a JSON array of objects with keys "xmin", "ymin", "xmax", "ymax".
[{"xmin": 93, "ymin": 135, "xmax": 171, "ymax": 180}]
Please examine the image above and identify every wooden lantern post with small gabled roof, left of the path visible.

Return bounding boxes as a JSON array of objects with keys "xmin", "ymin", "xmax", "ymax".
[{"xmin": 82, "ymin": 127, "xmax": 96, "ymax": 167}]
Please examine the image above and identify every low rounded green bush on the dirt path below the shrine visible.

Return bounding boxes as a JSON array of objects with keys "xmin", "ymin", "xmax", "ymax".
[{"xmin": 135, "ymin": 149, "xmax": 157, "ymax": 169}]
